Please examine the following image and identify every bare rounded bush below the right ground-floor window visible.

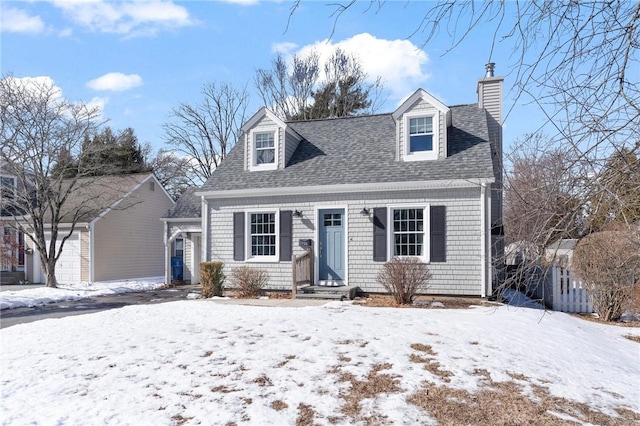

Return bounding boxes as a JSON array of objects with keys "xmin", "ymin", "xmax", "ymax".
[{"xmin": 378, "ymin": 257, "xmax": 431, "ymax": 305}]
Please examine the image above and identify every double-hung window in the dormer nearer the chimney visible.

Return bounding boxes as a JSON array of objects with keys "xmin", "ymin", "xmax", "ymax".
[{"xmin": 404, "ymin": 111, "xmax": 439, "ymax": 161}]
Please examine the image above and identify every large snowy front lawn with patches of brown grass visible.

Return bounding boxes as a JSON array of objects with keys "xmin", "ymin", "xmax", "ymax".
[{"xmin": 0, "ymin": 300, "xmax": 640, "ymax": 425}]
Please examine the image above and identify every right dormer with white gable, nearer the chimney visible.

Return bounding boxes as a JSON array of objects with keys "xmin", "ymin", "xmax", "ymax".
[{"xmin": 392, "ymin": 89, "xmax": 451, "ymax": 161}]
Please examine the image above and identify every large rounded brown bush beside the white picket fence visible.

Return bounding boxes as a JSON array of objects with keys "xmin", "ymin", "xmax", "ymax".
[{"xmin": 573, "ymin": 231, "xmax": 640, "ymax": 321}]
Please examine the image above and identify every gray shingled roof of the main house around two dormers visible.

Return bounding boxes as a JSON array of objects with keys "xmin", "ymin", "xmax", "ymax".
[{"xmin": 199, "ymin": 104, "xmax": 494, "ymax": 191}]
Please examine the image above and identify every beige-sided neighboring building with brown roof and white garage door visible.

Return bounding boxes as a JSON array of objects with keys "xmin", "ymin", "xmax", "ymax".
[{"xmin": 1, "ymin": 173, "xmax": 174, "ymax": 284}]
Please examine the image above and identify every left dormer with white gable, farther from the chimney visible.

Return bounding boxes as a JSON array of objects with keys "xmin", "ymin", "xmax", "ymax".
[{"xmin": 241, "ymin": 107, "xmax": 302, "ymax": 172}]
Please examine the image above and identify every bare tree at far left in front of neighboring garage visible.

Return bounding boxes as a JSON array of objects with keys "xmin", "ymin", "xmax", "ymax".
[{"xmin": 0, "ymin": 75, "xmax": 99, "ymax": 287}]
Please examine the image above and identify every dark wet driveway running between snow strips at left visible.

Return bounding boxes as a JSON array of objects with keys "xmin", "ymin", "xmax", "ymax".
[{"xmin": 0, "ymin": 285, "xmax": 201, "ymax": 328}]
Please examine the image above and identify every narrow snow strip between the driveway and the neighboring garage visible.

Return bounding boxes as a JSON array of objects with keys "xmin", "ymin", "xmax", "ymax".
[{"xmin": 0, "ymin": 277, "xmax": 164, "ymax": 310}]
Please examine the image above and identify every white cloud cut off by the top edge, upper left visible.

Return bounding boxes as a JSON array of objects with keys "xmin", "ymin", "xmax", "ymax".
[{"xmin": 52, "ymin": 0, "xmax": 196, "ymax": 36}]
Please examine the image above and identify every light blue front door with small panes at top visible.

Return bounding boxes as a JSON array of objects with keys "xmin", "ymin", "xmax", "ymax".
[{"xmin": 318, "ymin": 209, "xmax": 345, "ymax": 285}]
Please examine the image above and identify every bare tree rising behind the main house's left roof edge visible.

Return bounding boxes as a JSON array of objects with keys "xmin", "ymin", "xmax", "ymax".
[{"xmin": 163, "ymin": 83, "xmax": 249, "ymax": 184}]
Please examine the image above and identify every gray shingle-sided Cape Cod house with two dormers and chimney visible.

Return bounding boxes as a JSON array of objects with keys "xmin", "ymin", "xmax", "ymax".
[{"xmin": 165, "ymin": 64, "xmax": 503, "ymax": 296}]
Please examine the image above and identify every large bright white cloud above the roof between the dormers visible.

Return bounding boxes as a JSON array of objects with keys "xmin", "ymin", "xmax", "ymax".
[{"xmin": 297, "ymin": 33, "xmax": 430, "ymax": 101}]
